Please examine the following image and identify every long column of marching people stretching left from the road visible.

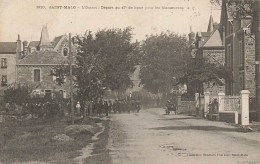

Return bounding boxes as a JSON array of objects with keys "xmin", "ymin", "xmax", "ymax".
[{"xmin": 5, "ymin": 96, "xmax": 141, "ymax": 118}]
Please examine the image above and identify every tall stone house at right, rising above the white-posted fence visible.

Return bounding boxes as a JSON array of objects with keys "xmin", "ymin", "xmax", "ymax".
[{"xmin": 221, "ymin": 0, "xmax": 255, "ymax": 96}]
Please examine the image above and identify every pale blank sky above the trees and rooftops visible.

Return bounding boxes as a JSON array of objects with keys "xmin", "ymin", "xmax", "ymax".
[{"xmin": 0, "ymin": 0, "xmax": 220, "ymax": 42}]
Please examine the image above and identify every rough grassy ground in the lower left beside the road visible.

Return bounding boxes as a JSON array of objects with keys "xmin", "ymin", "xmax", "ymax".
[{"xmin": 0, "ymin": 117, "xmax": 99, "ymax": 163}]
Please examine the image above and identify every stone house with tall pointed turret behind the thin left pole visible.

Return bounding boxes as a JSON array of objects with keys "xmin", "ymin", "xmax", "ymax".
[{"xmin": 16, "ymin": 26, "xmax": 76, "ymax": 98}]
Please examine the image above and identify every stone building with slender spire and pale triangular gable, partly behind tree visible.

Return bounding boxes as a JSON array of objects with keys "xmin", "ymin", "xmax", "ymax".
[{"xmin": 189, "ymin": 15, "xmax": 225, "ymax": 94}]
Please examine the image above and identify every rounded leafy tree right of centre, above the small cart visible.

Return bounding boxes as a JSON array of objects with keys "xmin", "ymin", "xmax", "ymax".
[{"xmin": 140, "ymin": 32, "xmax": 188, "ymax": 94}]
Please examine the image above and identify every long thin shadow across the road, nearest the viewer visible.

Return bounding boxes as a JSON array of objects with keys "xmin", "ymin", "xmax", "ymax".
[{"xmin": 150, "ymin": 126, "xmax": 250, "ymax": 133}]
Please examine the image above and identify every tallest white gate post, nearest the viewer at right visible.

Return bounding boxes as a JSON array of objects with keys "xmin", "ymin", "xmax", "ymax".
[{"xmin": 240, "ymin": 90, "xmax": 250, "ymax": 125}]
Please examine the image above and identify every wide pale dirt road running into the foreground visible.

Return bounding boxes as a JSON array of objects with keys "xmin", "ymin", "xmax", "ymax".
[{"xmin": 107, "ymin": 108, "xmax": 260, "ymax": 164}]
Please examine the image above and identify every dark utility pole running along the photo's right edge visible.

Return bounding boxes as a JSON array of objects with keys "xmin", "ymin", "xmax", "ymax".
[{"xmin": 254, "ymin": 0, "xmax": 260, "ymax": 121}]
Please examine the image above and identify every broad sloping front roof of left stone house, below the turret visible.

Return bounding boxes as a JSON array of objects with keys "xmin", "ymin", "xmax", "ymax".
[{"xmin": 18, "ymin": 51, "xmax": 68, "ymax": 65}]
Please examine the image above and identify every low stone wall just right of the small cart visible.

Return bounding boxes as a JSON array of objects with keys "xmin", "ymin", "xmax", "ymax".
[{"xmin": 177, "ymin": 101, "xmax": 196, "ymax": 115}]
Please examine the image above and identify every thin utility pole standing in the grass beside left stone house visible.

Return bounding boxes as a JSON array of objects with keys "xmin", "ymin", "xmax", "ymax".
[{"xmin": 69, "ymin": 33, "xmax": 74, "ymax": 124}]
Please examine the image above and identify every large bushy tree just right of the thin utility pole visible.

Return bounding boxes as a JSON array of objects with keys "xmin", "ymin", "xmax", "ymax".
[{"xmin": 73, "ymin": 27, "xmax": 138, "ymax": 102}]
